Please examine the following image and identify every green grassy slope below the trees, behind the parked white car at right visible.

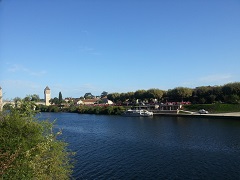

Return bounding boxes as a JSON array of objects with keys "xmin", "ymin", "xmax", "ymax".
[{"xmin": 184, "ymin": 103, "xmax": 240, "ymax": 113}]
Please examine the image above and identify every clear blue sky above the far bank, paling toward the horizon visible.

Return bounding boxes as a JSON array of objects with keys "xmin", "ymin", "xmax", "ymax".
[{"xmin": 0, "ymin": 0, "xmax": 240, "ymax": 99}]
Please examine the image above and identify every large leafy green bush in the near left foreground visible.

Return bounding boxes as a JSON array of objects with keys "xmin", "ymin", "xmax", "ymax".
[{"xmin": 0, "ymin": 101, "xmax": 73, "ymax": 179}]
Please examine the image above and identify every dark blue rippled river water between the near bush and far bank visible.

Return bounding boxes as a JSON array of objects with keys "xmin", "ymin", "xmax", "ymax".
[{"xmin": 40, "ymin": 113, "xmax": 240, "ymax": 179}]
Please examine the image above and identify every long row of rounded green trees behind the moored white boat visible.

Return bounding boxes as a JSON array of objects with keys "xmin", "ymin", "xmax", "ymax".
[{"xmin": 107, "ymin": 82, "xmax": 240, "ymax": 104}]
